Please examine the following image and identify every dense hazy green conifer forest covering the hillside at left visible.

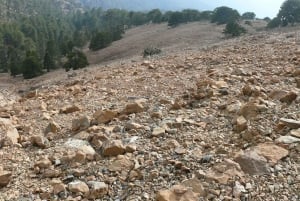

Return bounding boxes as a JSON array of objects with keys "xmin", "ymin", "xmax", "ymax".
[{"xmin": 0, "ymin": 0, "xmax": 214, "ymax": 78}]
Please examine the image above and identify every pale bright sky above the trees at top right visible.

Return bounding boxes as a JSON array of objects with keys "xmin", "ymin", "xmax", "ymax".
[{"xmin": 205, "ymin": 0, "xmax": 284, "ymax": 18}]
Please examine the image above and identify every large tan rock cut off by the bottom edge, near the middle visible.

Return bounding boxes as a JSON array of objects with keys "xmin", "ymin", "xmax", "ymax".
[{"xmin": 156, "ymin": 185, "xmax": 199, "ymax": 201}]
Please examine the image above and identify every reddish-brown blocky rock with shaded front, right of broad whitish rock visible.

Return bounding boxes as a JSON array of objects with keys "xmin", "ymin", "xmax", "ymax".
[{"xmin": 102, "ymin": 140, "xmax": 126, "ymax": 156}]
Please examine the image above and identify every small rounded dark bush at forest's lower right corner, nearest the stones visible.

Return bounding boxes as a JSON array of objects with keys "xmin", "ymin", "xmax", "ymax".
[{"xmin": 64, "ymin": 50, "xmax": 89, "ymax": 71}]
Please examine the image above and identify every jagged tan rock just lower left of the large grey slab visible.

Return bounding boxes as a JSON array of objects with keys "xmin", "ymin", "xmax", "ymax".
[{"xmin": 204, "ymin": 159, "xmax": 244, "ymax": 184}]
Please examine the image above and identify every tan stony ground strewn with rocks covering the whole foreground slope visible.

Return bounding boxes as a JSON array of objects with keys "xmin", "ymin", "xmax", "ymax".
[{"xmin": 0, "ymin": 29, "xmax": 300, "ymax": 201}]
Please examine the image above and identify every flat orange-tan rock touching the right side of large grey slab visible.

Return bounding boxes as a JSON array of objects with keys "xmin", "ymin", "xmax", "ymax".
[{"xmin": 253, "ymin": 143, "xmax": 289, "ymax": 164}]
